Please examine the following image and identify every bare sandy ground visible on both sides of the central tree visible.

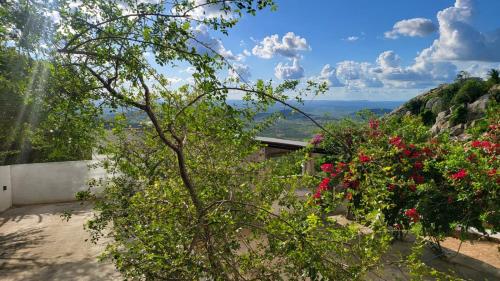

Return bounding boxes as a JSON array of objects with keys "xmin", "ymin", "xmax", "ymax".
[{"xmin": 0, "ymin": 203, "xmax": 500, "ymax": 281}]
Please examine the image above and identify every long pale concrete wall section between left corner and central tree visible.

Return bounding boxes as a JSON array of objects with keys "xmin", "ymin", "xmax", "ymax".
[{"xmin": 10, "ymin": 161, "xmax": 107, "ymax": 205}]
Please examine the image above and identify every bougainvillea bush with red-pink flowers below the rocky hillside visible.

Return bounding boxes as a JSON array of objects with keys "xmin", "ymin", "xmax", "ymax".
[{"xmin": 311, "ymin": 108, "xmax": 500, "ymax": 242}]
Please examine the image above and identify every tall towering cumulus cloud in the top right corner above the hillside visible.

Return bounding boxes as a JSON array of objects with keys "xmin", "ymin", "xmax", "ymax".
[{"xmin": 420, "ymin": 0, "xmax": 500, "ymax": 62}]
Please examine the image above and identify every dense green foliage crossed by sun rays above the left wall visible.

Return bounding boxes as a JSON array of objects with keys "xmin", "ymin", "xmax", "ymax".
[{"xmin": 0, "ymin": 47, "xmax": 99, "ymax": 164}]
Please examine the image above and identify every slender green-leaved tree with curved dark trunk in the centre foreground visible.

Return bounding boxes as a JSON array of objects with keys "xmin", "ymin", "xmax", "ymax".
[{"xmin": 54, "ymin": 0, "xmax": 389, "ymax": 280}]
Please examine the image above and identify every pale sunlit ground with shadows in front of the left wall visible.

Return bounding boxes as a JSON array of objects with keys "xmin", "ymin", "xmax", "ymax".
[{"xmin": 0, "ymin": 203, "xmax": 119, "ymax": 281}]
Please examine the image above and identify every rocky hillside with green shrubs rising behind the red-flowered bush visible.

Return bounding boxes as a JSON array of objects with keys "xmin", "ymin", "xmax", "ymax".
[{"xmin": 389, "ymin": 76, "xmax": 500, "ymax": 136}]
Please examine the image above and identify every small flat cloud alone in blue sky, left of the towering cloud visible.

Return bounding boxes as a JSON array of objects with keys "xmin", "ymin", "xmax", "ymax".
[{"xmin": 384, "ymin": 18, "xmax": 437, "ymax": 39}]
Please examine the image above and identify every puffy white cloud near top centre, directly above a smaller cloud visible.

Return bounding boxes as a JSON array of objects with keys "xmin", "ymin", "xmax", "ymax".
[{"xmin": 252, "ymin": 32, "xmax": 311, "ymax": 59}]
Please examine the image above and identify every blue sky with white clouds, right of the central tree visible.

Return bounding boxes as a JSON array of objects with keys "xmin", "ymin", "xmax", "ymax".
[{"xmin": 171, "ymin": 0, "xmax": 500, "ymax": 100}]
